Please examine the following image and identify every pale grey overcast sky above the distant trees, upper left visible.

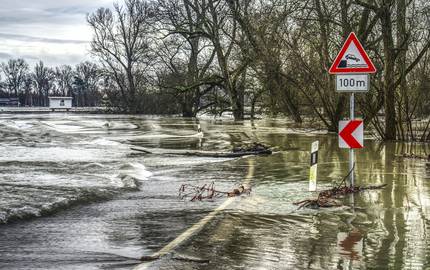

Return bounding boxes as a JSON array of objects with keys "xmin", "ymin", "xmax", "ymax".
[{"xmin": 0, "ymin": 0, "xmax": 113, "ymax": 66}]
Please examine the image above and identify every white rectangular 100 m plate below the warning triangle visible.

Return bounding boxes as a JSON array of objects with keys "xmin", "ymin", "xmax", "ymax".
[{"xmin": 336, "ymin": 74, "xmax": 369, "ymax": 92}]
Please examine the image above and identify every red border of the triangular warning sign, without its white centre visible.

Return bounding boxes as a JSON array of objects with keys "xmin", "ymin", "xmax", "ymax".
[{"xmin": 328, "ymin": 32, "xmax": 376, "ymax": 74}]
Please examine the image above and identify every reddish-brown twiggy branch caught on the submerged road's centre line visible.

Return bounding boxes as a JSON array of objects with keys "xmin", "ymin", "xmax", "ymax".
[{"xmin": 179, "ymin": 182, "xmax": 251, "ymax": 202}]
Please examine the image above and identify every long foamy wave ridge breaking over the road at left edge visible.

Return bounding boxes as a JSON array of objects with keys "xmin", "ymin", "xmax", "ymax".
[{"xmin": 0, "ymin": 163, "xmax": 152, "ymax": 223}]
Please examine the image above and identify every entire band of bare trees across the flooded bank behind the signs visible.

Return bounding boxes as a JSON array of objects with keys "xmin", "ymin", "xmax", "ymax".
[{"xmin": 2, "ymin": 0, "xmax": 430, "ymax": 141}]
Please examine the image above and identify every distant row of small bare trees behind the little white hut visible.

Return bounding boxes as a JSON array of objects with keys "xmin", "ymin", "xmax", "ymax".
[{"xmin": 0, "ymin": 58, "xmax": 102, "ymax": 106}]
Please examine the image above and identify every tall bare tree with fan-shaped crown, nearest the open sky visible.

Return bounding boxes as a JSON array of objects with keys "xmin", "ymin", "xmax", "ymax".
[{"xmin": 87, "ymin": 0, "xmax": 153, "ymax": 113}]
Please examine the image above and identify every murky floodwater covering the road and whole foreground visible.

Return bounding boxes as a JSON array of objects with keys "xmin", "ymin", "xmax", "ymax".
[{"xmin": 0, "ymin": 113, "xmax": 430, "ymax": 269}]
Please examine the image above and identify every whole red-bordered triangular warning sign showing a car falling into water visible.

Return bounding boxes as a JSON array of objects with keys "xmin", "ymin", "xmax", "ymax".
[{"xmin": 328, "ymin": 32, "xmax": 376, "ymax": 74}]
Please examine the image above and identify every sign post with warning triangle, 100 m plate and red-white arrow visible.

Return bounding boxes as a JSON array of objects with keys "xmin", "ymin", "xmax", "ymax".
[{"xmin": 329, "ymin": 32, "xmax": 376, "ymax": 185}]
